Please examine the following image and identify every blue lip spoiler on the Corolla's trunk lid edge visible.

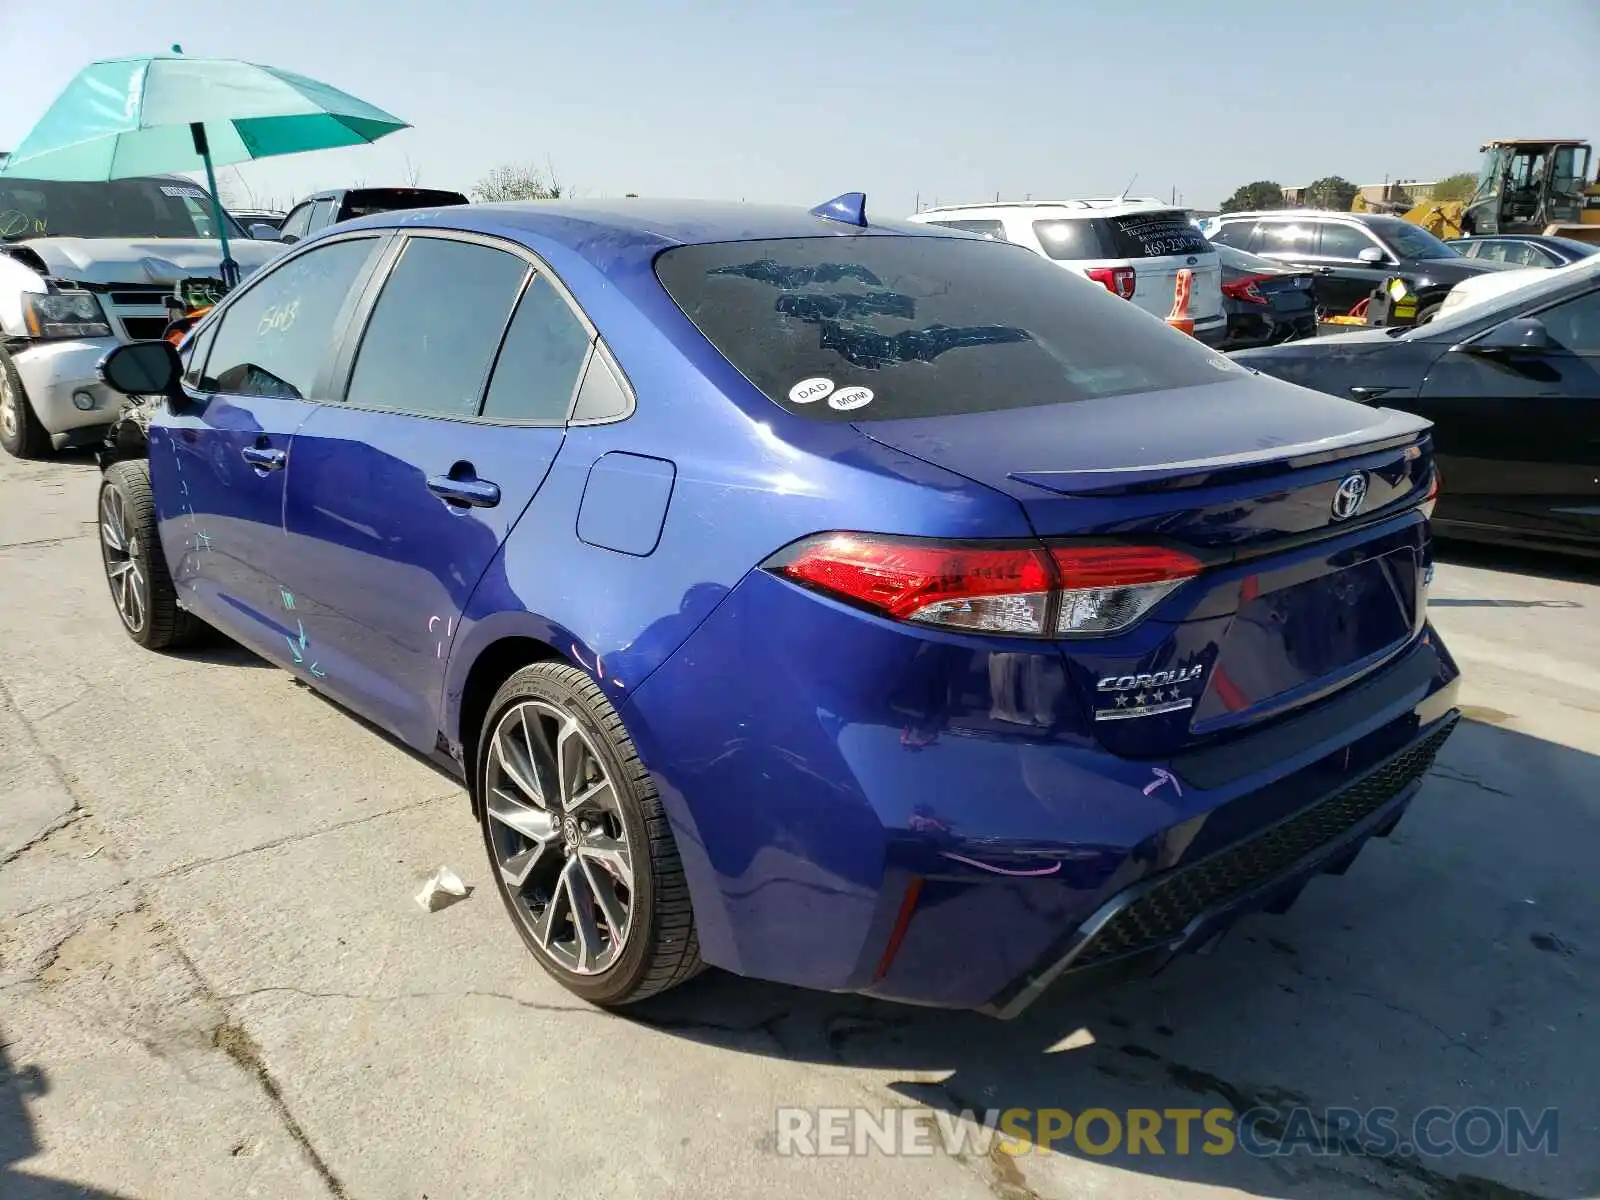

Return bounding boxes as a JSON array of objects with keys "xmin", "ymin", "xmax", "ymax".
[{"xmin": 1008, "ymin": 408, "xmax": 1434, "ymax": 496}]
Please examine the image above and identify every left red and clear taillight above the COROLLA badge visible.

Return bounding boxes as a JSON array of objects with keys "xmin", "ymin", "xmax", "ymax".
[{"xmin": 763, "ymin": 533, "xmax": 1202, "ymax": 637}]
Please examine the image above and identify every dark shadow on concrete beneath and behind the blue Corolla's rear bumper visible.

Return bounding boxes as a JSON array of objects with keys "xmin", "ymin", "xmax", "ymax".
[{"xmin": 629, "ymin": 720, "xmax": 1600, "ymax": 1200}]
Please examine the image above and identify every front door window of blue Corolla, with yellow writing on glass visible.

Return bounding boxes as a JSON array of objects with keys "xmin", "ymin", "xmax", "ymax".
[{"xmin": 203, "ymin": 237, "xmax": 378, "ymax": 400}]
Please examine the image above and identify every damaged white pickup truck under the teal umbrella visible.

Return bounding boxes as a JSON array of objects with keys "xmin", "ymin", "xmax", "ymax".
[{"xmin": 0, "ymin": 176, "xmax": 283, "ymax": 458}]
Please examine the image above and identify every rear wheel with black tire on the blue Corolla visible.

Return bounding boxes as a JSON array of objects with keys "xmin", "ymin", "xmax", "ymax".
[{"xmin": 474, "ymin": 662, "xmax": 702, "ymax": 1006}]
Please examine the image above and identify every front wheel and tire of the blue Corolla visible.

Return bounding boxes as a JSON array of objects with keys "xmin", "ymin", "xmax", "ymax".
[{"xmin": 96, "ymin": 459, "xmax": 206, "ymax": 650}]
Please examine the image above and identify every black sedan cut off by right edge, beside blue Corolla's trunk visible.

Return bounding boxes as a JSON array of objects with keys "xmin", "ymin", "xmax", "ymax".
[{"xmin": 1232, "ymin": 256, "xmax": 1600, "ymax": 554}]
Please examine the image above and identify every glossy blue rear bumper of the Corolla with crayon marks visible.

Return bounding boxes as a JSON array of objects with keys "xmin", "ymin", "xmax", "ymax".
[{"xmin": 622, "ymin": 560, "xmax": 1459, "ymax": 1013}]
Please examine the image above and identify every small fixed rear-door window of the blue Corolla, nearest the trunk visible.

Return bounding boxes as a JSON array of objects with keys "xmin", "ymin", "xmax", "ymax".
[{"xmin": 483, "ymin": 275, "xmax": 589, "ymax": 424}]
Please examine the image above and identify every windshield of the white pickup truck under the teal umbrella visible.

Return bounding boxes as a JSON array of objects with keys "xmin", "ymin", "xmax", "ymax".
[{"xmin": 0, "ymin": 176, "xmax": 245, "ymax": 242}]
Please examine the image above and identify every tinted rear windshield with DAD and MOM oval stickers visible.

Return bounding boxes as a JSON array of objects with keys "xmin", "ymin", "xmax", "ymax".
[{"xmin": 656, "ymin": 235, "xmax": 1242, "ymax": 421}]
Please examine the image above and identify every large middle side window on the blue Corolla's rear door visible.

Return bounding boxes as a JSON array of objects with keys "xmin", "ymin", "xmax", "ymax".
[{"xmin": 346, "ymin": 237, "xmax": 528, "ymax": 418}]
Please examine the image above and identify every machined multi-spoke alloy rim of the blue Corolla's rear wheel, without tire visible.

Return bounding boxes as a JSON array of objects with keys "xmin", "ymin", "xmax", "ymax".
[{"xmin": 485, "ymin": 699, "xmax": 634, "ymax": 976}]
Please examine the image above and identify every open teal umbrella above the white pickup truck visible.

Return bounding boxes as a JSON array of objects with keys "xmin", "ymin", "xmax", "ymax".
[{"xmin": 0, "ymin": 46, "xmax": 410, "ymax": 286}]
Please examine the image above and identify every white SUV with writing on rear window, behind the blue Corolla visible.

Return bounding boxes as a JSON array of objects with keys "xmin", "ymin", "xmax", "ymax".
[{"xmin": 910, "ymin": 197, "xmax": 1227, "ymax": 346}]
